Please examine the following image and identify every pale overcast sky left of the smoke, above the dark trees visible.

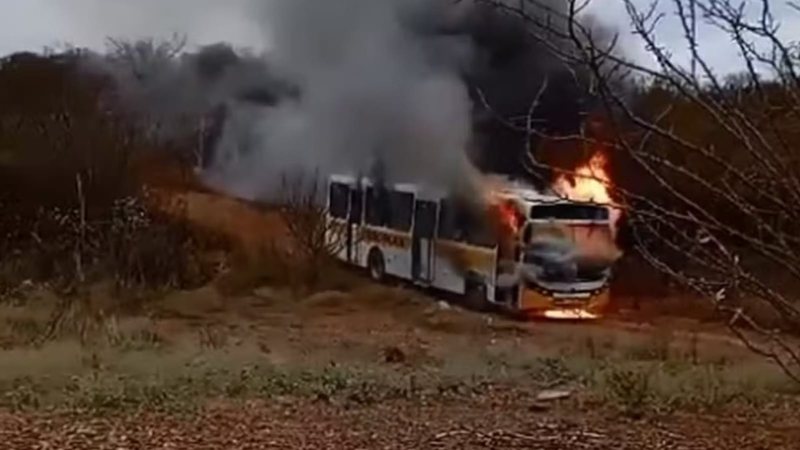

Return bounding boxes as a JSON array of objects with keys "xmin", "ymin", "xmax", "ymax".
[{"xmin": 0, "ymin": 0, "xmax": 263, "ymax": 55}]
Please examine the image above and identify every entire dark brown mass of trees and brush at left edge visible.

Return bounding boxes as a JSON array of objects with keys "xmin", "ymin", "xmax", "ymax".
[{"xmin": 0, "ymin": 50, "xmax": 228, "ymax": 306}]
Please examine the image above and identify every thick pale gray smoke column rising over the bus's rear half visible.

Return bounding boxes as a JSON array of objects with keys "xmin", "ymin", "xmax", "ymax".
[{"xmin": 208, "ymin": 0, "xmax": 482, "ymax": 198}]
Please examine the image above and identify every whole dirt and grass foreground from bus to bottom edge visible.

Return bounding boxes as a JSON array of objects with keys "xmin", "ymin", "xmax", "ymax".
[{"xmin": 0, "ymin": 283, "xmax": 800, "ymax": 450}]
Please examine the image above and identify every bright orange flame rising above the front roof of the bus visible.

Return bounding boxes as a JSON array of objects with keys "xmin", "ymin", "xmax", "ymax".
[{"xmin": 553, "ymin": 151, "xmax": 622, "ymax": 231}]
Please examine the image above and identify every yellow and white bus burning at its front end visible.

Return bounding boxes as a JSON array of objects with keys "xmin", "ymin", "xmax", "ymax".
[{"xmin": 327, "ymin": 175, "xmax": 613, "ymax": 319}]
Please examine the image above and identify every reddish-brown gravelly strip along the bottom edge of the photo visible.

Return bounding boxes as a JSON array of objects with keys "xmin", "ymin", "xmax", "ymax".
[{"xmin": 0, "ymin": 397, "xmax": 800, "ymax": 450}]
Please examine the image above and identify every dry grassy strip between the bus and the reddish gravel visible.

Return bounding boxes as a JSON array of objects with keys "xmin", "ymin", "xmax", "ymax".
[{"xmin": 0, "ymin": 272, "xmax": 797, "ymax": 424}]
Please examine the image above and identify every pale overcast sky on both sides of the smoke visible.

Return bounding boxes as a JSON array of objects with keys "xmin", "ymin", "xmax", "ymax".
[{"xmin": 0, "ymin": 0, "xmax": 800, "ymax": 72}]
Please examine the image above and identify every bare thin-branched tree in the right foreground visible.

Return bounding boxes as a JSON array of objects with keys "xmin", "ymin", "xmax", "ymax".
[{"xmin": 485, "ymin": 0, "xmax": 800, "ymax": 382}]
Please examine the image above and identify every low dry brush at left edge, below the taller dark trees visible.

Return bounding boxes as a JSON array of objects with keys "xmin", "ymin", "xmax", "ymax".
[{"xmin": 2, "ymin": 191, "xmax": 223, "ymax": 302}]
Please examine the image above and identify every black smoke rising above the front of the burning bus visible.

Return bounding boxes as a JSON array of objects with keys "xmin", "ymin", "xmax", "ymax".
[{"xmin": 453, "ymin": 0, "xmax": 613, "ymax": 181}]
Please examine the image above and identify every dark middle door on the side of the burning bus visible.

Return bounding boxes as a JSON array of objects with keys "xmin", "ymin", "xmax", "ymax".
[{"xmin": 411, "ymin": 200, "xmax": 438, "ymax": 283}]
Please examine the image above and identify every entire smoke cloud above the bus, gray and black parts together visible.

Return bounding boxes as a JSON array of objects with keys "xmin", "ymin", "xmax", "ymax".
[{"xmin": 92, "ymin": 0, "xmax": 620, "ymax": 199}]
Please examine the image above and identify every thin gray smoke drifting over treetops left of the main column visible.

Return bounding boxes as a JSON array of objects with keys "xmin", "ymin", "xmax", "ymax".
[{"xmin": 86, "ymin": 38, "xmax": 293, "ymax": 139}]
